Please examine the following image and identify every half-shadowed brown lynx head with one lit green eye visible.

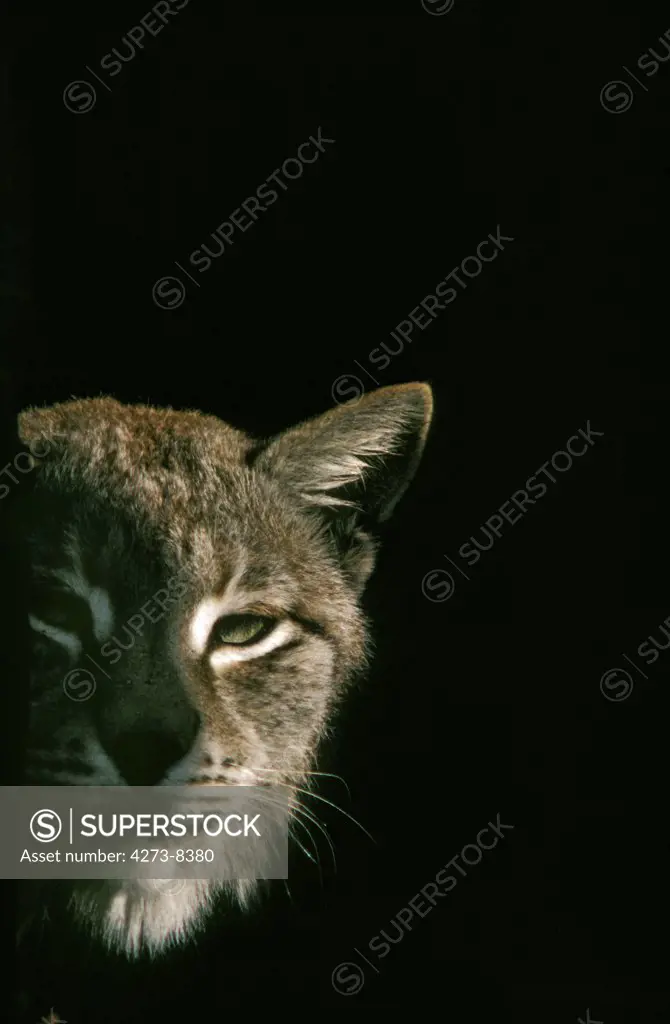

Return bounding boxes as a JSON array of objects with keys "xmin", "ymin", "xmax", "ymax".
[{"xmin": 19, "ymin": 383, "xmax": 432, "ymax": 956}]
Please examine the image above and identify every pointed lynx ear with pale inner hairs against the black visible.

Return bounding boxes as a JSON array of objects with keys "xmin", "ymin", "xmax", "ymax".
[{"xmin": 254, "ymin": 383, "xmax": 432, "ymax": 526}]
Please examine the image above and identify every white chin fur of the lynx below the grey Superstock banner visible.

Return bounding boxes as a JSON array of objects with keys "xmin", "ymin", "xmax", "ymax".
[{"xmin": 70, "ymin": 879, "xmax": 255, "ymax": 959}]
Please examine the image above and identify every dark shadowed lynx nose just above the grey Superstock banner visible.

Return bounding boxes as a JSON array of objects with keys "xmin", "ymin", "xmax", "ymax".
[{"xmin": 104, "ymin": 716, "xmax": 200, "ymax": 785}]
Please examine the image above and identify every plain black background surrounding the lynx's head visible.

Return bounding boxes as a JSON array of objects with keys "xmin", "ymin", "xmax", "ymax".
[{"xmin": 2, "ymin": 0, "xmax": 670, "ymax": 1024}]
